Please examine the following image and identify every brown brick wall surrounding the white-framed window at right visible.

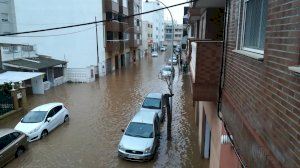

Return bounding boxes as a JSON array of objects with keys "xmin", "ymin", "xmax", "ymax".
[{"xmin": 222, "ymin": 0, "xmax": 300, "ymax": 167}]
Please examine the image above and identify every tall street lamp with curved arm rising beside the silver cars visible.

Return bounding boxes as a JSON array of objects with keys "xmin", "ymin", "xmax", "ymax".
[{"xmin": 146, "ymin": 0, "xmax": 174, "ymax": 140}]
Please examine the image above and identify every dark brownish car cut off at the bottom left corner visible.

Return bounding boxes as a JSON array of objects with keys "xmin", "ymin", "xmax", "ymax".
[{"xmin": 0, "ymin": 129, "xmax": 28, "ymax": 167}]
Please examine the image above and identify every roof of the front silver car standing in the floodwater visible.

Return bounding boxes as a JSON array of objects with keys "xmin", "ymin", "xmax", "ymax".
[{"xmin": 131, "ymin": 109, "xmax": 157, "ymax": 124}]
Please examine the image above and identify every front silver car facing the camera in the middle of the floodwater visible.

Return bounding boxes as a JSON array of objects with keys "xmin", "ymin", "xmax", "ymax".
[{"xmin": 118, "ymin": 110, "xmax": 160, "ymax": 161}]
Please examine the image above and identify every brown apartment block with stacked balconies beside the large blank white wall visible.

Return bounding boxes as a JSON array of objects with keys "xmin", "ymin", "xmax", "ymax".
[{"xmin": 103, "ymin": 0, "xmax": 131, "ymax": 73}]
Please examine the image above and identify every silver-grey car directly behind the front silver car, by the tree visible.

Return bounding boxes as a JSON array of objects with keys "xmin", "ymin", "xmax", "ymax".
[{"xmin": 141, "ymin": 93, "xmax": 165, "ymax": 122}]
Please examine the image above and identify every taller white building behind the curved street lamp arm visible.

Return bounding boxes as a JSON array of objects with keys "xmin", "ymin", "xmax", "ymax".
[{"xmin": 142, "ymin": 1, "xmax": 165, "ymax": 50}]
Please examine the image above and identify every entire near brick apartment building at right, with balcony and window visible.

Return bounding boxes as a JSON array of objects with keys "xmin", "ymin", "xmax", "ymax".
[{"xmin": 188, "ymin": 0, "xmax": 300, "ymax": 168}]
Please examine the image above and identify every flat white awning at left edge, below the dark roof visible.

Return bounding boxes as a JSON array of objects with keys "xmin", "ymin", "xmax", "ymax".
[{"xmin": 0, "ymin": 71, "xmax": 45, "ymax": 84}]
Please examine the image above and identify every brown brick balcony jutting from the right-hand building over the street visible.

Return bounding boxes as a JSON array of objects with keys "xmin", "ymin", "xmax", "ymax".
[{"xmin": 189, "ymin": 40, "xmax": 223, "ymax": 102}]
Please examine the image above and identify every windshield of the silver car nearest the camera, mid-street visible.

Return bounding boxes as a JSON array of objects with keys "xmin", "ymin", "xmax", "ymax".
[{"xmin": 125, "ymin": 122, "xmax": 153, "ymax": 138}]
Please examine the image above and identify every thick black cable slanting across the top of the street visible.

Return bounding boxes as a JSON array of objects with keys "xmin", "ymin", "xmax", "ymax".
[{"xmin": 0, "ymin": 0, "xmax": 196, "ymax": 36}]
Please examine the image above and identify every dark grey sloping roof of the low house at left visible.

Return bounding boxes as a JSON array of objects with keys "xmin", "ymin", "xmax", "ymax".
[{"xmin": 3, "ymin": 55, "xmax": 67, "ymax": 70}]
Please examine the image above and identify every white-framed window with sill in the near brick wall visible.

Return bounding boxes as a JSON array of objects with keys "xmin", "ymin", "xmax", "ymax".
[{"xmin": 241, "ymin": 0, "xmax": 268, "ymax": 54}]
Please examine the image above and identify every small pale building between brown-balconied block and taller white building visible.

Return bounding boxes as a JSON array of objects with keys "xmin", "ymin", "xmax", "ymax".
[{"xmin": 142, "ymin": 21, "xmax": 153, "ymax": 53}]
